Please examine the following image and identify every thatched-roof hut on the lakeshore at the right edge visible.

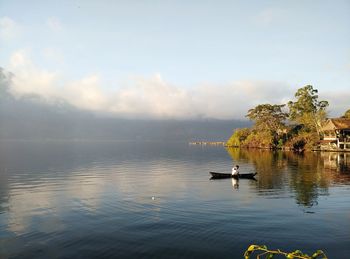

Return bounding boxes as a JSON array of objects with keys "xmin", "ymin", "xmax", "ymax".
[{"xmin": 320, "ymin": 118, "xmax": 350, "ymax": 151}]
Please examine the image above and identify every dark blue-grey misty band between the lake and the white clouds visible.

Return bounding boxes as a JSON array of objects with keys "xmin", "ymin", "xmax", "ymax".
[{"xmin": 0, "ymin": 68, "xmax": 250, "ymax": 142}]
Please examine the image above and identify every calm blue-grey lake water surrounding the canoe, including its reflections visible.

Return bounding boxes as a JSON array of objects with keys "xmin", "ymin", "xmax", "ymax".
[{"xmin": 0, "ymin": 141, "xmax": 350, "ymax": 258}]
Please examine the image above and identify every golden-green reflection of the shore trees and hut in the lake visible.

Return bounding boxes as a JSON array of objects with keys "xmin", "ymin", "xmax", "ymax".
[{"xmin": 227, "ymin": 148, "xmax": 350, "ymax": 207}]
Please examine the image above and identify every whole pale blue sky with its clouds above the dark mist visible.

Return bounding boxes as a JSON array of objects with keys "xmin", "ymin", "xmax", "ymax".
[{"xmin": 0, "ymin": 0, "xmax": 350, "ymax": 119}]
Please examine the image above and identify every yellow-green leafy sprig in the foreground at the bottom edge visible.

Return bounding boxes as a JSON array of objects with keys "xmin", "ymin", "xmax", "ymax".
[{"xmin": 244, "ymin": 245, "xmax": 327, "ymax": 259}]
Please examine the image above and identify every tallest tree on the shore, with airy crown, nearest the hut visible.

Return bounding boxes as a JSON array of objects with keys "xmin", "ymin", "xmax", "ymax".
[{"xmin": 288, "ymin": 85, "xmax": 328, "ymax": 134}]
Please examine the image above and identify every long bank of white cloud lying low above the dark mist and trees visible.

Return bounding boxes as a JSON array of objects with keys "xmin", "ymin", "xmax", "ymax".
[{"xmin": 8, "ymin": 50, "xmax": 350, "ymax": 119}]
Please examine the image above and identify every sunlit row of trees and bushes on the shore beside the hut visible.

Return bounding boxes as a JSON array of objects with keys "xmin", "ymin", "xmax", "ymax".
[{"xmin": 227, "ymin": 85, "xmax": 350, "ymax": 151}]
